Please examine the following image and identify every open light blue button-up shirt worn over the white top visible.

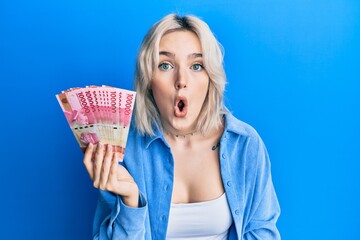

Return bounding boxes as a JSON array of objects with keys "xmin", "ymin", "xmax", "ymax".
[{"xmin": 93, "ymin": 113, "xmax": 280, "ymax": 240}]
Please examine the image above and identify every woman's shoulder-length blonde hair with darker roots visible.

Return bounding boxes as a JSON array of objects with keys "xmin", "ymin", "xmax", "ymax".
[{"xmin": 134, "ymin": 14, "xmax": 226, "ymax": 135}]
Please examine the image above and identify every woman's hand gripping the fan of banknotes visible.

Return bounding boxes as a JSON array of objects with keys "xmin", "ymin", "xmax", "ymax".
[{"xmin": 83, "ymin": 143, "xmax": 139, "ymax": 207}]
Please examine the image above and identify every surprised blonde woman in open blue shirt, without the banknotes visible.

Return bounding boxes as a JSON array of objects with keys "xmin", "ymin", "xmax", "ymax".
[{"xmin": 84, "ymin": 14, "xmax": 280, "ymax": 240}]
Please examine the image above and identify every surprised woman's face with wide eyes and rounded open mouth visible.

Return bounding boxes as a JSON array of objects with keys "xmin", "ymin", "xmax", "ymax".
[{"xmin": 151, "ymin": 31, "xmax": 210, "ymax": 134}]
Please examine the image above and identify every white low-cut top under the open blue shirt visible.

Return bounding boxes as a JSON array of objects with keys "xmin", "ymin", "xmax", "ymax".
[{"xmin": 166, "ymin": 193, "xmax": 233, "ymax": 240}]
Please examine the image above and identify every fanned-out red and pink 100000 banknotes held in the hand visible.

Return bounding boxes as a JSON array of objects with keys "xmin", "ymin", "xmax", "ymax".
[{"xmin": 56, "ymin": 86, "xmax": 136, "ymax": 153}]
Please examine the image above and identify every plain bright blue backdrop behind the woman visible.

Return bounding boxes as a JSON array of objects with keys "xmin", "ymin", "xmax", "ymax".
[{"xmin": 0, "ymin": 0, "xmax": 360, "ymax": 240}]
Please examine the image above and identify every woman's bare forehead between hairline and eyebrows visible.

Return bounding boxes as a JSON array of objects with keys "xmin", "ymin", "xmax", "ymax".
[{"xmin": 159, "ymin": 30, "xmax": 202, "ymax": 54}]
